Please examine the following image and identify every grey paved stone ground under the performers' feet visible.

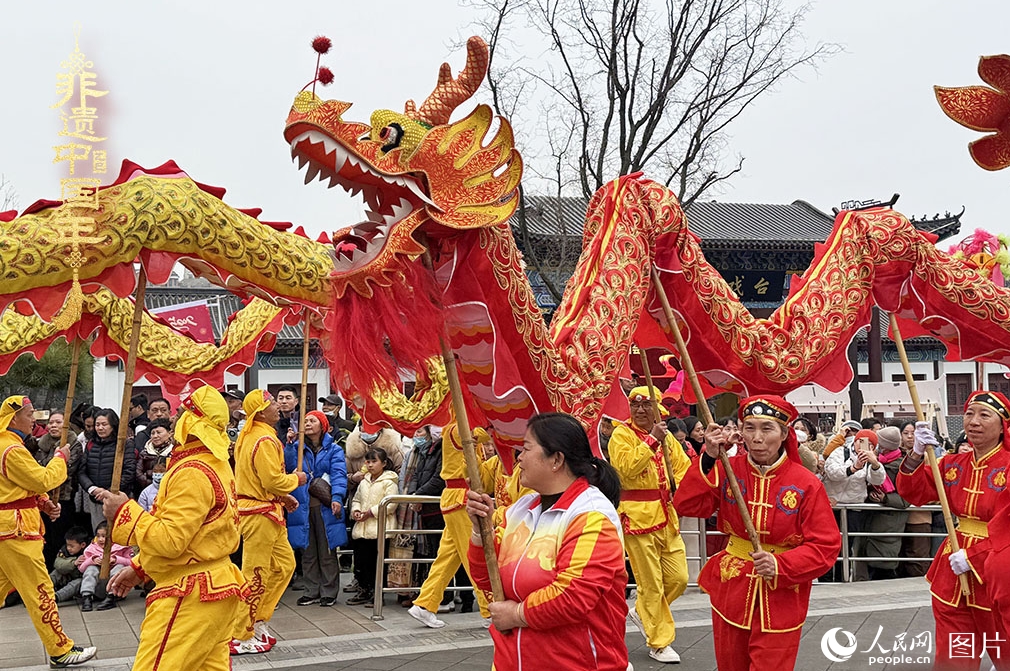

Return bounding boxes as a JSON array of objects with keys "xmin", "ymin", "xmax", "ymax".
[{"xmin": 0, "ymin": 578, "xmax": 989, "ymax": 671}]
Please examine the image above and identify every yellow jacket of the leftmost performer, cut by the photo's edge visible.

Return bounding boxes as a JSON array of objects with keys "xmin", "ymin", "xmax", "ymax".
[{"xmin": 0, "ymin": 430, "xmax": 67, "ymax": 541}]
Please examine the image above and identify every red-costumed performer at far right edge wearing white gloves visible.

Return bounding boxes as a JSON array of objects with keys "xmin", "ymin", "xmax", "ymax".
[{"xmin": 897, "ymin": 391, "xmax": 1010, "ymax": 670}]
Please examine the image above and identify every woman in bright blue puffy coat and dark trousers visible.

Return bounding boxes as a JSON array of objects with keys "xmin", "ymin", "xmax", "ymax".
[{"xmin": 284, "ymin": 410, "xmax": 347, "ymax": 606}]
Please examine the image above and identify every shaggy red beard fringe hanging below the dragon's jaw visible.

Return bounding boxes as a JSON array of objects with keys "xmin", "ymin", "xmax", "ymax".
[{"xmin": 325, "ymin": 262, "xmax": 444, "ymax": 396}]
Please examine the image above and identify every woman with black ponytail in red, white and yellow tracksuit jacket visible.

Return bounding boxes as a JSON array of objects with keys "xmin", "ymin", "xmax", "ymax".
[{"xmin": 467, "ymin": 412, "xmax": 628, "ymax": 671}]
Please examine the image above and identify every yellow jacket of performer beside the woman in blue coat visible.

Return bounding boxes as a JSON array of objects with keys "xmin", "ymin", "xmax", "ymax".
[{"xmin": 235, "ymin": 421, "xmax": 298, "ymax": 526}]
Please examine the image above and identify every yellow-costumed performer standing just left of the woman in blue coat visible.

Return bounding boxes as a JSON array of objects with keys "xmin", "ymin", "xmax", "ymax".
[{"xmin": 231, "ymin": 389, "xmax": 306, "ymax": 655}]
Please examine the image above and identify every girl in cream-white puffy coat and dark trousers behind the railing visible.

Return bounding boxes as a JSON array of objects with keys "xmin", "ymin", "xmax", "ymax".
[{"xmin": 347, "ymin": 448, "xmax": 400, "ymax": 605}]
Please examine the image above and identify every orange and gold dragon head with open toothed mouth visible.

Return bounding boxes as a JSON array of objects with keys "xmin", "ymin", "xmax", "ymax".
[{"xmin": 284, "ymin": 37, "xmax": 522, "ymax": 297}]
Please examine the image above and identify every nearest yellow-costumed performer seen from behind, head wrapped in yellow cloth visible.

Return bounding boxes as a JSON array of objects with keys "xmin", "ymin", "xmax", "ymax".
[{"xmin": 102, "ymin": 386, "xmax": 249, "ymax": 671}]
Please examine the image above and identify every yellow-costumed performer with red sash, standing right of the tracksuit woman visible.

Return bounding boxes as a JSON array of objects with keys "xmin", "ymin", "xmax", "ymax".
[{"xmin": 609, "ymin": 387, "xmax": 691, "ymax": 664}]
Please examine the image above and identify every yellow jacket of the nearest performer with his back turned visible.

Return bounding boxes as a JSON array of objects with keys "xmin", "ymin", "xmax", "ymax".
[{"xmin": 112, "ymin": 441, "xmax": 247, "ymax": 603}]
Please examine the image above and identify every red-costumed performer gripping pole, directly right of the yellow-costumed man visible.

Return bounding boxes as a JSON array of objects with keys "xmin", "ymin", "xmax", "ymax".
[{"xmin": 674, "ymin": 396, "xmax": 841, "ymax": 671}]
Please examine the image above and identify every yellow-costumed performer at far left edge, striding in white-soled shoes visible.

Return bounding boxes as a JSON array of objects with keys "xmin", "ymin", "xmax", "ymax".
[{"xmin": 0, "ymin": 396, "xmax": 95, "ymax": 669}]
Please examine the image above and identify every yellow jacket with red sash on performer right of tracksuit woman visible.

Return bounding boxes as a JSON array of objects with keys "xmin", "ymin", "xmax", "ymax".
[{"xmin": 608, "ymin": 423, "xmax": 691, "ymax": 536}]
